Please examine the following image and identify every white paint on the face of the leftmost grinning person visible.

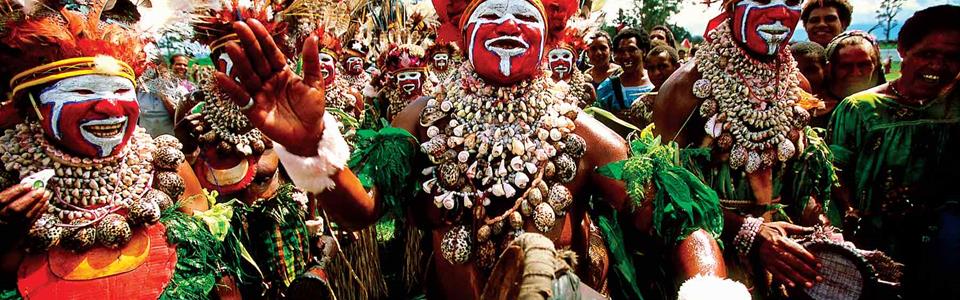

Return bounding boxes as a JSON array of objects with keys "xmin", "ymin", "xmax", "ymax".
[{"xmin": 39, "ymin": 74, "xmax": 138, "ymax": 156}]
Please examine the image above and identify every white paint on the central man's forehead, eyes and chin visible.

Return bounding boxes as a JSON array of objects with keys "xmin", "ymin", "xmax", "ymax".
[{"xmin": 467, "ymin": 0, "xmax": 546, "ymax": 76}]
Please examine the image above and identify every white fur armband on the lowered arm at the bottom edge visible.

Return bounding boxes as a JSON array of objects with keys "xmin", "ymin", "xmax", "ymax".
[{"xmin": 677, "ymin": 275, "xmax": 750, "ymax": 300}]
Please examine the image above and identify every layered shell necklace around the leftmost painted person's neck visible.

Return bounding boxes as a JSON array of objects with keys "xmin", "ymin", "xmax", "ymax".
[{"xmin": 0, "ymin": 123, "xmax": 184, "ymax": 251}]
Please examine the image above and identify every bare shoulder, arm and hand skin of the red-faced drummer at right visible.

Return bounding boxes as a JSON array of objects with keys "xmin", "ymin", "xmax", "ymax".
[{"xmin": 653, "ymin": 37, "xmax": 822, "ymax": 287}]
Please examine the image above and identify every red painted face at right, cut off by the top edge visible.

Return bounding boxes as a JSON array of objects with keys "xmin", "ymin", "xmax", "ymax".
[{"xmin": 732, "ymin": 0, "xmax": 801, "ymax": 55}]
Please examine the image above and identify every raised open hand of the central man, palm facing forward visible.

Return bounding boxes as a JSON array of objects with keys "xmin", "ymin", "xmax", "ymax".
[{"xmin": 216, "ymin": 19, "xmax": 326, "ymax": 157}]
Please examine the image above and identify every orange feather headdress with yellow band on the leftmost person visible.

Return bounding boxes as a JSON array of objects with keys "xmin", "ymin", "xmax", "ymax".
[{"xmin": 0, "ymin": 0, "xmax": 145, "ymax": 99}]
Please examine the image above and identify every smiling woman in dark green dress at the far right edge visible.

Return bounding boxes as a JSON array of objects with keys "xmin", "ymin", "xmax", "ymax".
[{"xmin": 829, "ymin": 5, "xmax": 960, "ymax": 299}]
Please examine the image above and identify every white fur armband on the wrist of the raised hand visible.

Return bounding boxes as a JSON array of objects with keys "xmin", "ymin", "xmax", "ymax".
[{"xmin": 273, "ymin": 113, "xmax": 350, "ymax": 193}]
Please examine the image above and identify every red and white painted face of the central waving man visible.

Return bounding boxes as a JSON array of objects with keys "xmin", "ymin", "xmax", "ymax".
[{"xmin": 463, "ymin": 0, "xmax": 546, "ymax": 85}]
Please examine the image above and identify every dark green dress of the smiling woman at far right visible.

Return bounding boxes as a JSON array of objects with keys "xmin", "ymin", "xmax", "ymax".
[{"xmin": 829, "ymin": 92, "xmax": 960, "ymax": 298}]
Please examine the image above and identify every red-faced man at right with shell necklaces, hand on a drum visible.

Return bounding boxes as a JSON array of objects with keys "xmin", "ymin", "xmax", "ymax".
[{"xmin": 653, "ymin": 0, "xmax": 837, "ymax": 297}]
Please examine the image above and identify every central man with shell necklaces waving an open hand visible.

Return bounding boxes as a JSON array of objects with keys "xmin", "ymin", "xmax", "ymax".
[{"xmin": 217, "ymin": 0, "xmax": 746, "ymax": 299}]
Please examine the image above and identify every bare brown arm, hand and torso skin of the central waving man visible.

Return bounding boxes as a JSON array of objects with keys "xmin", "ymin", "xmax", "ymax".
[{"xmin": 217, "ymin": 20, "xmax": 725, "ymax": 299}]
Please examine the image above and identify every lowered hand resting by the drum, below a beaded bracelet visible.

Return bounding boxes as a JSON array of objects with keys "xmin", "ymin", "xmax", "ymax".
[{"xmin": 757, "ymin": 222, "xmax": 823, "ymax": 287}]
